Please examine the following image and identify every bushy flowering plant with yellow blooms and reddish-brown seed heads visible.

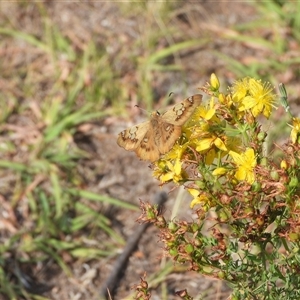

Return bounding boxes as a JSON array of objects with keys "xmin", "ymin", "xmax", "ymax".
[{"xmin": 135, "ymin": 74, "xmax": 300, "ymax": 300}]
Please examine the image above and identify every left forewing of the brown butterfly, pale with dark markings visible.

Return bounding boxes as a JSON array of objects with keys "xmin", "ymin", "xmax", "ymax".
[{"xmin": 117, "ymin": 121, "xmax": 150, "ymax": 151}]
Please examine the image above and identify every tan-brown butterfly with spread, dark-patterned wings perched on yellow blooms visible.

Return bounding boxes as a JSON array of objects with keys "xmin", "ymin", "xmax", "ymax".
[{"xmin": 117, "ymin": 94, "xmax": 202, "ymax": 162}]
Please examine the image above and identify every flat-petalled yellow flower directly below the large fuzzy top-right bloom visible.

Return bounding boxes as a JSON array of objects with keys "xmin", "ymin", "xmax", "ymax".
[{"xmin": 229, "ymin": 148, "xmax": 256, "ymax": 184}]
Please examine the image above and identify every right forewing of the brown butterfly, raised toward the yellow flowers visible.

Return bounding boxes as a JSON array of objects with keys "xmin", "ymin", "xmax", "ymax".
[{"xmin": 161, "ymin": 94, "xmax": 202, "ymax": 126}]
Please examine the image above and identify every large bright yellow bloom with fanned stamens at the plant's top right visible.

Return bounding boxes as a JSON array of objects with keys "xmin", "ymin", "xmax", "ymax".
[{"xmin": 233, "ymin": 78, "xmax": 275, "ymax": 118}]
